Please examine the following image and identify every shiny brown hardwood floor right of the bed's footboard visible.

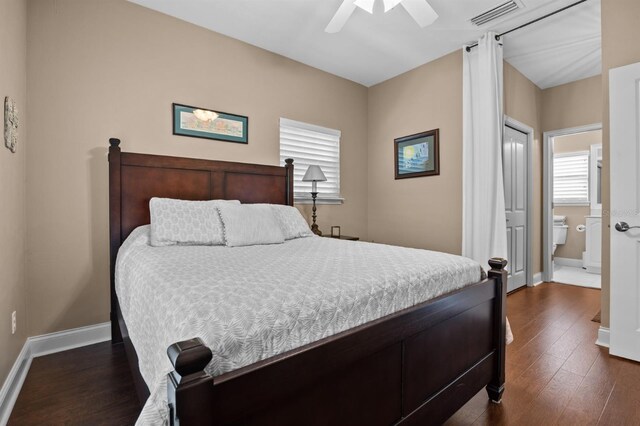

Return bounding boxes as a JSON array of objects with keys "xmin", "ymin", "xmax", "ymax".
[{"xmin": 446, "ymin": 283, "xmax": 640, "ymax": 426}]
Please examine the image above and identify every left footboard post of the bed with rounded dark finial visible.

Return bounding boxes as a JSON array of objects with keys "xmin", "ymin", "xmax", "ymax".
[{"xmin": 167, "ymin": 338, "xmax": 213, "ymax": 425}]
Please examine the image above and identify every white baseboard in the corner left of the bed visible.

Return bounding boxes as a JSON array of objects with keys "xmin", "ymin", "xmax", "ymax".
[{"xmin": 0, "ymin": 322, "xmax": 111, "ymax": 425}]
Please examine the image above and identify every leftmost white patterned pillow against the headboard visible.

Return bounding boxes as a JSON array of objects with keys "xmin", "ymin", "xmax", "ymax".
[{"xmin": 149, "ymin": 197, "xmax": 240, "ymax": 247}]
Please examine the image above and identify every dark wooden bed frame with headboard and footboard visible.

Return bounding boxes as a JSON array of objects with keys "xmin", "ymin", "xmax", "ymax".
[{"xmin": 109, "ymin": 139, "xmax": 507, "ymax": 426}]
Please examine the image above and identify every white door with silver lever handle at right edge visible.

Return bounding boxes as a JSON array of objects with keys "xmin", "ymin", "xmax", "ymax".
[{"xmin": 609, "ymin": 63, "xmax": 640, "ymax": 361}]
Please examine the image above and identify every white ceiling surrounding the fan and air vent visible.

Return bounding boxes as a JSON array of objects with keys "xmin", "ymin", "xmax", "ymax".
[{"xmin": 130, "ymin": 0, "xmax": 601, "ymax": 89}]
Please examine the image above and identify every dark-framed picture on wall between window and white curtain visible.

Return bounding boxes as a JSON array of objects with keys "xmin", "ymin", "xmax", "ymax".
[{"xmin": 393, "ymin": 129, "xmax": 440, "ymax": 179}]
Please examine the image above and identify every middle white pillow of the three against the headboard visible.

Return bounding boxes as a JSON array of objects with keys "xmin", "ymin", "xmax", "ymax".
[{"xmin": 218, "ymin": 204, "xmax": 284, "ymax": 247}]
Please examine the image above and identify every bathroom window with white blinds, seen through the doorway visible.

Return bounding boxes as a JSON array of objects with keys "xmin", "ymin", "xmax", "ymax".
[{"xmin": 553, "ymin": 151, "xmax": 589, "ymax": 205}]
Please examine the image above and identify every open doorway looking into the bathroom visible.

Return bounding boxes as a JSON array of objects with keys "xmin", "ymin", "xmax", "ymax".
[{"xmin": 542, "ymin": 124, "xmax": 602, "ymax": 288}]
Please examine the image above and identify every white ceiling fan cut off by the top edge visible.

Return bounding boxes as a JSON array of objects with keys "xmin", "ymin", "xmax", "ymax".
[{"xmin": 324, "ymin": 0, "xmax": 438, "ymax": 33}]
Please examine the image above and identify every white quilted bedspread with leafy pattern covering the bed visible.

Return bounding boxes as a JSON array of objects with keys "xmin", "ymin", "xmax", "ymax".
[{"xmin": 116, "ymin": 226, "xmax": 481, "ymax": 424}]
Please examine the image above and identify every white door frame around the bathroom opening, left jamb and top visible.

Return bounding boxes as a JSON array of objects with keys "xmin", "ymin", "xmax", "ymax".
[{"xmin": 542, "ymin": 123, "xmax": 602, "ymax": 282}]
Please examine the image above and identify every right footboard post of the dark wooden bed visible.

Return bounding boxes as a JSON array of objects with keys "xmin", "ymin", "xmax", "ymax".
[{"xmin": 487, "ymin": 257, "xmax": 507, "ymax": 403}]
